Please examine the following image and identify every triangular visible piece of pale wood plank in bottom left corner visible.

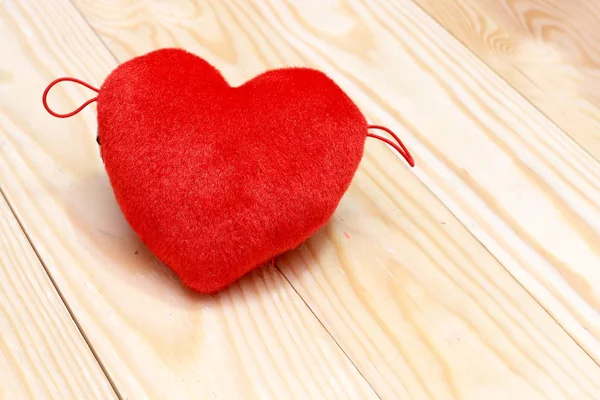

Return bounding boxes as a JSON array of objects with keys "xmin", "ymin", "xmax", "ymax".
[{"xmin": 0, "ymin": 194, "xmax": 116, "ymax": 400}]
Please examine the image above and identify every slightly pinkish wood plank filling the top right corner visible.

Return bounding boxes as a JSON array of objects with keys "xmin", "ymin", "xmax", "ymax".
[{"xmin": 415, "ymin": 0, "xmax": 600, "ymax": 159}]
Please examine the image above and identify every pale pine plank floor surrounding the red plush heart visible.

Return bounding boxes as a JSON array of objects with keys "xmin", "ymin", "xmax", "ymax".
[{"xmin": 0, "ymin": 0, "xmax": 600, "ymax": 400}]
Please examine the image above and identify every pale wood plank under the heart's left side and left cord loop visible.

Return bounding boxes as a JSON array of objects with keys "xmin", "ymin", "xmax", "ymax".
[{"xmin": 0, "ymin": 0, "xmax": 377, "ymax": 400}]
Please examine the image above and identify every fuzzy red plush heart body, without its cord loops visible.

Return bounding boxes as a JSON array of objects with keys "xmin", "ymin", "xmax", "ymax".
[{"xmin": 98, "ymin": 49, "xmax": 367, "ymax": 293}]
